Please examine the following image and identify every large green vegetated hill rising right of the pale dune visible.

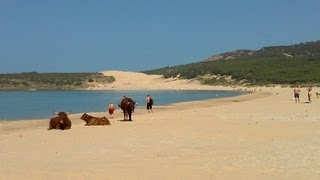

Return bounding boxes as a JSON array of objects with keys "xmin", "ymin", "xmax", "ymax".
[{"xmin": 143, "ymin": 41, "xmax": 320, "ymax": 85}]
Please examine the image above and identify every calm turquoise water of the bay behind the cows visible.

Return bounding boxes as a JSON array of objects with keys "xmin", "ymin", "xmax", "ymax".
[{"xmin": 0, "ymin": 90, "xmax": 243, "ymax": 120}]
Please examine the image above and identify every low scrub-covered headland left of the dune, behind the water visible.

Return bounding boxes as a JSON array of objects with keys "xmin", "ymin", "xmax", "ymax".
[{"xmin": 0, "ymin": 72, "xmax": 115, "ymax": 90}]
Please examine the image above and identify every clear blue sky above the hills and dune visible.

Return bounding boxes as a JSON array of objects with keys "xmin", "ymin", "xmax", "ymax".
[{"xmin": 0, "ymin": 0, "xmax": 320, "ymax": 73}]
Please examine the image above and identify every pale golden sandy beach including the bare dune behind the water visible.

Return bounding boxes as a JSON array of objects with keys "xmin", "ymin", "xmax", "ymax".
[{"xmin": 0, "ymin": 71, "xmax": 320, "ymax": 180}]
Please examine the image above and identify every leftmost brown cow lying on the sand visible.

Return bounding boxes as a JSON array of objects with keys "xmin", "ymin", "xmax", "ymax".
[{"xmin": 48, "ymin": 112, "xmax": 71, "ymax": 130}]
